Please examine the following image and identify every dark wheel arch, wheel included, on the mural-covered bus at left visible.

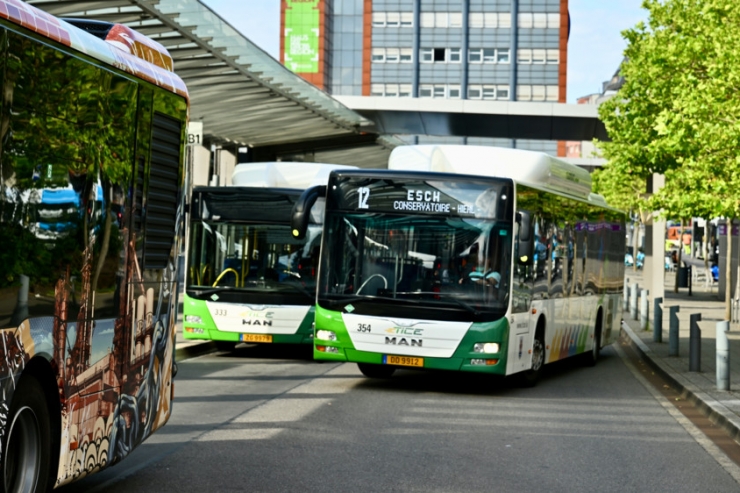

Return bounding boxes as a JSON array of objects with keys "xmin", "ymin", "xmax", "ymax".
[{"xmin": 0, "ymin": 357, "xmax": 61, "ymax": 491}]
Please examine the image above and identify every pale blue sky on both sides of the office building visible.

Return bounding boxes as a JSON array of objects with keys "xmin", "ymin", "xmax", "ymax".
[{"xmin": 201, "ymin": 0, "xmax": 647, "ymax": 103}]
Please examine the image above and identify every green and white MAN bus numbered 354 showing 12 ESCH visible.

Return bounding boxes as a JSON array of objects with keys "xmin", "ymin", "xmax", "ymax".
[{"xmin": 298, "ymin": 146, "xmax": 625, "ymax": 384}]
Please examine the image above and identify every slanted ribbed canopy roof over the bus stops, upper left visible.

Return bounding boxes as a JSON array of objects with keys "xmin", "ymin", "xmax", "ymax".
[{"xmin": 27, "ymin": 0, "xmax": 392, "ymax": 165}]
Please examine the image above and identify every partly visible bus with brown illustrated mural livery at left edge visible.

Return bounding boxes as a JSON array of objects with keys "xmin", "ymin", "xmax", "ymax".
[{"xmin": 0, "ymin": 0, "xmax": 188, "ymax": 492}]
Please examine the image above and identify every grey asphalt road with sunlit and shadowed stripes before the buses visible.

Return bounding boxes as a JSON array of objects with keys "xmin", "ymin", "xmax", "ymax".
[{"xmin": 59, "ymin": 346, "xmax": 740, "ymax": 493}]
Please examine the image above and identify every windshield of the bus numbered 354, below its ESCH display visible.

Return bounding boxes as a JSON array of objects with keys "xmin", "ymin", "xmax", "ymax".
[{"xmin": 318, "ymin": 212, "xmax": 512, "ymax": 320}]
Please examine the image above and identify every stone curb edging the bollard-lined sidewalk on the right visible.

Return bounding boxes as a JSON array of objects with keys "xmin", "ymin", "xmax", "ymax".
[{"xmin": 621, "ymin": 321, "xmax": 740, "ymax": 441}]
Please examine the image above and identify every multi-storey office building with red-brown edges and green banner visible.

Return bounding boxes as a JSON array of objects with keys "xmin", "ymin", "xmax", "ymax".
[{"xmin": 280, "ymin": 0, "xmax": 569, "ymax": 156}]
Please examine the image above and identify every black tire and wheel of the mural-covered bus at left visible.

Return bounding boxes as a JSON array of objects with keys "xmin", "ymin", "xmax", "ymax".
[{"xmin": 0, "ymin": 376, "xmax": 51, "ymax": 493}]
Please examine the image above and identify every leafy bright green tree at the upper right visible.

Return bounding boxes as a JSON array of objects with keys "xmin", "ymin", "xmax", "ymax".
[{"xmin": 599, "ymin": 0, "xmax": 740, "ymax": 320}]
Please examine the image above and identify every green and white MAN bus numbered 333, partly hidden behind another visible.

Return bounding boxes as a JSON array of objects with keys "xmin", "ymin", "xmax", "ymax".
[{"xmin": 183, "ymin": 162, "xmax": 347, "ymax": 350}]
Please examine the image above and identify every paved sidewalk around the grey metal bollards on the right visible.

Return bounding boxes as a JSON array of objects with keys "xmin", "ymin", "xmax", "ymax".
[{"xmin": 622, "ymin": 268, "xmax": 740, "ymax": 440}]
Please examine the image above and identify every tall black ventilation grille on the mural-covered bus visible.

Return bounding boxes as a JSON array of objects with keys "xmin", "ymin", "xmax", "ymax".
[{"xmin": 144, "ymin": 113, "xmax": 182, "ymax": 269}]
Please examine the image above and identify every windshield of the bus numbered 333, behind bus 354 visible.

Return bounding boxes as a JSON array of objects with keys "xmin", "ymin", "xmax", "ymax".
[{"xmin": 187, "ymin": 220, "xmax": 321, "ymax": 305}]
